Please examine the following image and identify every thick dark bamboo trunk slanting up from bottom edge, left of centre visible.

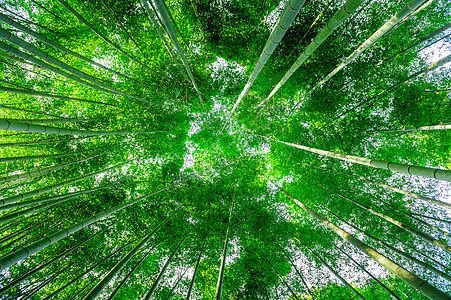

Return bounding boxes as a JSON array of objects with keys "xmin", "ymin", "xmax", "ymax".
[{"xmin": 83, "ymin": 202, "xmax": 182, "ymax": 300}]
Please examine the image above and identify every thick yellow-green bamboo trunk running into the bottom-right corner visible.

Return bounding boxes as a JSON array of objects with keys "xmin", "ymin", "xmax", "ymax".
[{"xmin": 276, "ymin": 185, "xmax": 451, "ymax": 300}]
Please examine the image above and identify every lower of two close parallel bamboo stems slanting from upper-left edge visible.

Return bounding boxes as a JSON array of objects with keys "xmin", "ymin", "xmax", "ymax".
[{"xmin": 0, "ymin": 27, "xmax": 149, "ymax": 103}]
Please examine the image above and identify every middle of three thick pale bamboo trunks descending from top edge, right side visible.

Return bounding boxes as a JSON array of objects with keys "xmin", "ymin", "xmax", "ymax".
[{"xmin": 258, "ymin": 0, "xmax": 364, "ymax": 107}]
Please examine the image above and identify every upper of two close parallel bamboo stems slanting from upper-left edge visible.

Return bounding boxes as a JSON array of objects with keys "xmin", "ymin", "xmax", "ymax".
[{"xmin": 0, "ymin": 13, "xmax": 146, "ymax": 85}]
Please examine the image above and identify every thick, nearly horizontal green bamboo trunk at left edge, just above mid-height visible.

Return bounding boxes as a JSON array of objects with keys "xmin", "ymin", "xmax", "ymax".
[{"xmin": 0, "ymin": 119, "xmax": 154, "ymax": 136}]
